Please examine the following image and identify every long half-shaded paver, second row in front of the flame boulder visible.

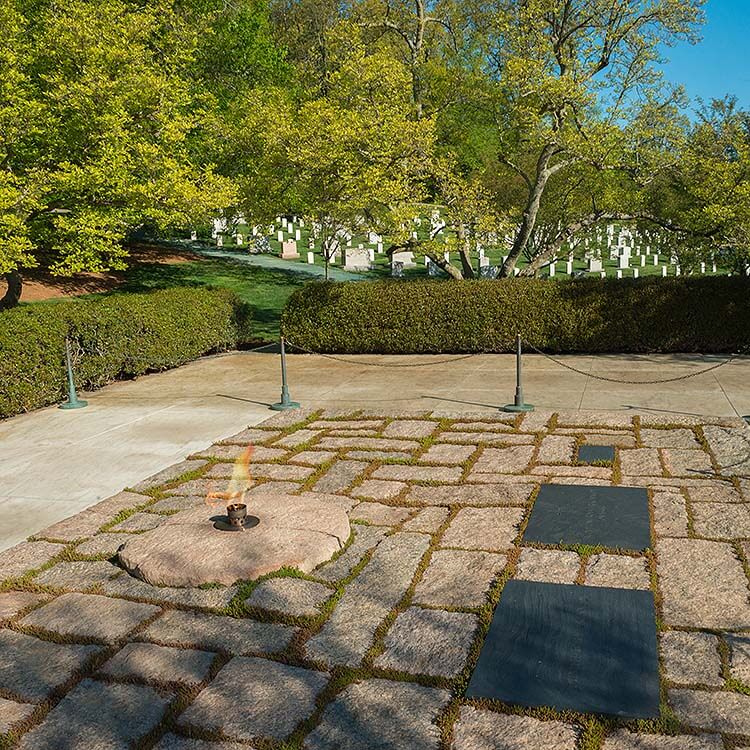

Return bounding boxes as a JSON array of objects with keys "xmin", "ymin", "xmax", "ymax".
[{"xmin": 138, "ymin": 609, "xmax": 294, "ymax": 655}]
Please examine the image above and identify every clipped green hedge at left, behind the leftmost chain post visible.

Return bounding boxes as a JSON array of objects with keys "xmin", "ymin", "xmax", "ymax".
[{"xmin": 0, "ymin": 287, "xmax": 249, "ymax": 417}]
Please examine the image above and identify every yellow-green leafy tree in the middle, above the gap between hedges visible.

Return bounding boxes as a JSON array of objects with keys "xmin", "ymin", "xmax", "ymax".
[{"xmin": 223, "ymin": 33, "xmax": 434, "ymax": 278}]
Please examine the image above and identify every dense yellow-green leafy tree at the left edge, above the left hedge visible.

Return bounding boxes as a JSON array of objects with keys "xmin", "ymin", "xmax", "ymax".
[{"xmin": 0, "ymin": 0, "xmax": 232, "ymax": 307}]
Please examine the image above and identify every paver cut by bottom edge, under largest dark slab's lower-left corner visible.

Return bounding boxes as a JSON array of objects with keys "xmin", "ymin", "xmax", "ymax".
[{"xmin": 451, "ymin": 706, "xmax": 578, "ymax": 750}]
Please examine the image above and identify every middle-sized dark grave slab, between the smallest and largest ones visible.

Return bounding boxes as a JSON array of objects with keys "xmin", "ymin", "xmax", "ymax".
[{"xmin": 524, "ymin": 484, "xmax": 651, "ymax": 550}]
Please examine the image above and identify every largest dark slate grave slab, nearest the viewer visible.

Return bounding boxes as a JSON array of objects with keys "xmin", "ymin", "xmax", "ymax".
[{"xmin": 467, "ymin": 580, "xmax": 659, "ymax": 719}]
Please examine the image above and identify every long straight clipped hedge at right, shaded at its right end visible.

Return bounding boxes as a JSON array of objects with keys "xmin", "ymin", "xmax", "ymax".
[{"xmin": 282, "ymin": 276, "xmax": 750, "ymax": 354}]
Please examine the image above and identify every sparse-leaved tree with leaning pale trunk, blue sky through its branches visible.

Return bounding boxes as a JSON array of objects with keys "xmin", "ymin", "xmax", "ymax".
[{"xmin": 487, "ymin": 0, "xmax": 703, "ymax": 276}]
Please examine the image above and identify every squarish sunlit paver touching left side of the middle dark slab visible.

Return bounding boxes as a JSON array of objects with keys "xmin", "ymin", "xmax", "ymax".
[{"xmin": 440, "ymin": 508, "xmax": 523, "ymax": 552}]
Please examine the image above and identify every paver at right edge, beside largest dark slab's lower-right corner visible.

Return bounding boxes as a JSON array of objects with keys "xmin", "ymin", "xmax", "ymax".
[{"xmin": 669, "ymin": 690, "xmax": 750, "ymax": 735}]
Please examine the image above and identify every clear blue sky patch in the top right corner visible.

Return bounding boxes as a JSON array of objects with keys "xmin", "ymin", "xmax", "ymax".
[{"xmin": 664, "ymin": 0, "xmax": 750, "ymax": 109}]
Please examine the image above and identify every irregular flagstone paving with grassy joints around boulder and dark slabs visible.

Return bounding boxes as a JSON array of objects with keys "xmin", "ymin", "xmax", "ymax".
[{"xmin": 0, "ymin": 409, "xmax": 750, "ymax": 750}]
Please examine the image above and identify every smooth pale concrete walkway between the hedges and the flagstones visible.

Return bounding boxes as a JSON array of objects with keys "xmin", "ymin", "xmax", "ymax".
[{"xmin": 0, "ymin": 353, "xmax": 750, "ymax": 549}]
